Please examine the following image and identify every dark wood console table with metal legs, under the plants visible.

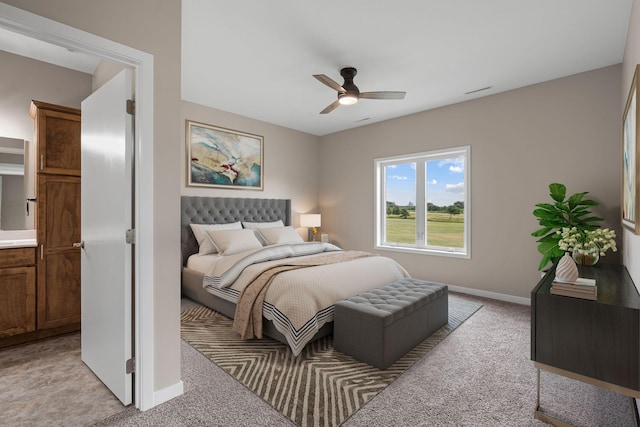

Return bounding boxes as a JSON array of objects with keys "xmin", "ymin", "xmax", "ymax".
[{"xmin": 531, "ymin": 264, "xmax": 640, "ymax": 425}]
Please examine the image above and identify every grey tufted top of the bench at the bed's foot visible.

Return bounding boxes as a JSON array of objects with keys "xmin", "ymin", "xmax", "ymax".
[{"xmin": 336, "ymin": 278, "xmax": 448, "ymax": 325}]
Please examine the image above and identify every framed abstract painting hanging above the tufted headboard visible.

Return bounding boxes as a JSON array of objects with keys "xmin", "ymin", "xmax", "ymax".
[{"xmin": 186, "ymin": 120, "xmax": 264, "ymax": 190}]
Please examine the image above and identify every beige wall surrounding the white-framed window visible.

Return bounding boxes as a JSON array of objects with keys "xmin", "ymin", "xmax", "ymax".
[{"xmin": 320, "ymin": 65, "xmax": 621, "ymax": 298}]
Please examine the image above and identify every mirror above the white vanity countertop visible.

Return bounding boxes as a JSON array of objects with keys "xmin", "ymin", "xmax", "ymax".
[{"xmin": 0, "ymin": 137, "xmax": 34, "ymax": 230}]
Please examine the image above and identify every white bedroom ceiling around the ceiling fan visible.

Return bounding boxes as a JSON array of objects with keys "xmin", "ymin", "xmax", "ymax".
[{"xmin": 182, "ymin": 0, "xmax": 633, "ymax": 135}]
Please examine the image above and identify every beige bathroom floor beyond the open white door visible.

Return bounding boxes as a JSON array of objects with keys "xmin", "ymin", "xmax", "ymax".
[{"xmin": 0, "ymin": 333, "xmax": 125, "ymax": 427}]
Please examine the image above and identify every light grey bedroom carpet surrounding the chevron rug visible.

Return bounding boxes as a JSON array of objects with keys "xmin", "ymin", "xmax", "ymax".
[{"xmin": 96, "ymin": 294, "xmax": 634, "ymax": 427}]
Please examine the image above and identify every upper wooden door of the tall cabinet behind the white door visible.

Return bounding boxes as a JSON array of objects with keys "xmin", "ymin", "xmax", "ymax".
[{"xmin": 31, "ymin": 101, "xmax": 81, "ymax": 176}]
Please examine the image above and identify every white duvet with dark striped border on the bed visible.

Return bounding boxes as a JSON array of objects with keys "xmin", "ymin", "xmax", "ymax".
[{"xmin": 203, "ymin": 242, "xmax": 409, "ymax": 356}]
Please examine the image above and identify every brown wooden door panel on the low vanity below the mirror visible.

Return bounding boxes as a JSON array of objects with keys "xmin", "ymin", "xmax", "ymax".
[{"xmin": 0, "ymin": 267, "xmax": 36, "ymax": 338}]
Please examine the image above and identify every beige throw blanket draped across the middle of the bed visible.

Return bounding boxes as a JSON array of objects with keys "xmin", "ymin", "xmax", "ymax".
[{"xmin": 233, "ymin": 251, "xmax": 376, "ymax": 339}]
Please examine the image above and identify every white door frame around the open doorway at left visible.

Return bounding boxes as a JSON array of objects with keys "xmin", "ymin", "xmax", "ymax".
[{"xmin": 0, "ymin": 3, "xmax": 156, "ymax": 411}]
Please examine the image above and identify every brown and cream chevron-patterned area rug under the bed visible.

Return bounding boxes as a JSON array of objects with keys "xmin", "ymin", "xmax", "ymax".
[{"xmin": 181, "ymin": 294, "xmax": 482, "ymax": 427}]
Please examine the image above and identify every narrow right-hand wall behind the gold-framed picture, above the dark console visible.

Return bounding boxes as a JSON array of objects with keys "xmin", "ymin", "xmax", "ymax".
[{"xmin": 620, "ymin": 0, "xmax": 640, "ymax": 290}]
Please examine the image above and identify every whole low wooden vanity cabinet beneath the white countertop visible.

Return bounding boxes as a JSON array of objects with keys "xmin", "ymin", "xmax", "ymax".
[{"xmin": 0, "ymin": 248, "xmax": 36, "ymax": 339}]
